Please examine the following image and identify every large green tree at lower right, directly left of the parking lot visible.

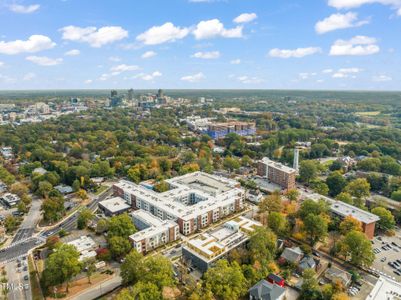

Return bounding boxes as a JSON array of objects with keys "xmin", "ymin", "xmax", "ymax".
[{"xmin": 339, "ymin": 230, "xmax": 375, "ymax": 266}]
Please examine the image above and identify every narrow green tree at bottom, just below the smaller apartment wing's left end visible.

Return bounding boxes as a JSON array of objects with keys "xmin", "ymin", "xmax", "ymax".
[{"xmin": 120, "ymin": 249, "xmax": 144, "ymax": 285}]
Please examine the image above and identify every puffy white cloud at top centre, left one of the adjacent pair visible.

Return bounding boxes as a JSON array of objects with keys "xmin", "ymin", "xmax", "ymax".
[{"xmin": 136, "ymin": 22, "xmax": 189, "ymax": 45}]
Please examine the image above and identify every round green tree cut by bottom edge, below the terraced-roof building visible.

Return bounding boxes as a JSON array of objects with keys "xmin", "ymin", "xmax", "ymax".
[{"xmin": 204, "ymin": 259, "xmax": 247, "ymax": 300}]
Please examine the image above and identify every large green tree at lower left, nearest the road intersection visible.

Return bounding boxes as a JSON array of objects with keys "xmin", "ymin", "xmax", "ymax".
[{"xmin": 44, "ymin": 244, "xmax": 81, "ymax": 293}]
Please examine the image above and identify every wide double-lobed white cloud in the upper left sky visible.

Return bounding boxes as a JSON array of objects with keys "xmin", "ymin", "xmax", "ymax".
[{"xmin": 60, "ymin": 26, "xmax": 128, "ymax": 48}]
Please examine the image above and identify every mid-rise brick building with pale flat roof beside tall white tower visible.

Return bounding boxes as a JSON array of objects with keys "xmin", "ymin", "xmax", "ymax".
[{"xmin": 257, "ymin": 157, "xmax": 297, "ymax": 191}]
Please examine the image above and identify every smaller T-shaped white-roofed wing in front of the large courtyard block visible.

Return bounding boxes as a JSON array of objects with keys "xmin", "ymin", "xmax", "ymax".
[{"xmin": 129, "ymin": 210, "xmax": 179, "ymax": 253}]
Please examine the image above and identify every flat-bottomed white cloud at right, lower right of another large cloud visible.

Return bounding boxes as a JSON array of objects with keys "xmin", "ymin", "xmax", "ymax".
[{"xmin": 330, "ymin": 35, "xmax": 380, "ymax": 56}]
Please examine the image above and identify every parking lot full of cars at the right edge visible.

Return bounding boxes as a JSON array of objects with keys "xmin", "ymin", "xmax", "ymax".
[{"xmin": 372, "ymin": 229, "xmax": 401, "ymax": 281}]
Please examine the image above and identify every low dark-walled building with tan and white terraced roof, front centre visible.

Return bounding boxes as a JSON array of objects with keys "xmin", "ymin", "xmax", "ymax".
[{"xmin": 182, "ymin": 216, "xmax": 262, "ymax": 272}]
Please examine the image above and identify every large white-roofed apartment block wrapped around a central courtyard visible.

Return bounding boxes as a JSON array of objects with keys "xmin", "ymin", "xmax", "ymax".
[{"xmin": 113, "ymin": 172, "xmax": 245, "ymax": 235}]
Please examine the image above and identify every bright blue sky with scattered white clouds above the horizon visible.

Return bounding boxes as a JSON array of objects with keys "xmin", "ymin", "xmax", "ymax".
[{"xmin": 0, "ymin": 0, "xmax": 401, "ymax": 90}]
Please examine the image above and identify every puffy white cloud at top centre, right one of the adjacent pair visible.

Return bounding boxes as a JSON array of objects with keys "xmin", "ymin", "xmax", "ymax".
[{"xmin": 192, "ymin": 19, "xmax": 242, "ymax": 40}]
